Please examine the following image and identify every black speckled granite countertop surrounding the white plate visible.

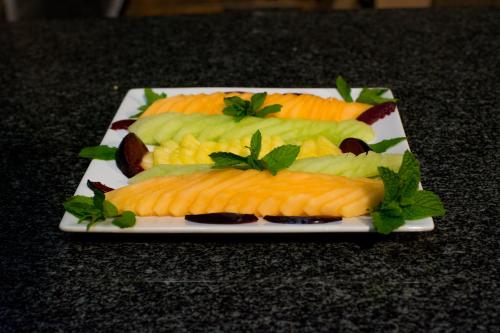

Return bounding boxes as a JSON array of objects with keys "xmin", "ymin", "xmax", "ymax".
[{"xmin": 0, "ymin": 9, "xmax": 500, "ymax": 332}]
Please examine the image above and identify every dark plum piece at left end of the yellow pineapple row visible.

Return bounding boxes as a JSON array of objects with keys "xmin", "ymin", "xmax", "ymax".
[{"xmin": 116, "ymin": 133, "xmax": 148, "ymax": 178}]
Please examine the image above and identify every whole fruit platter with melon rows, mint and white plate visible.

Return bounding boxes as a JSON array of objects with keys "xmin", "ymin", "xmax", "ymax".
[{"xmin": 60, "ymin": 77, "xmax": 444, "ymax": 234}]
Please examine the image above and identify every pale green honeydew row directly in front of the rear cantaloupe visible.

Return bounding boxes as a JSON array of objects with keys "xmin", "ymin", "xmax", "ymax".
[{"xmin": 129, "ymin": 112, "xmax": 375, "ymax": 146}]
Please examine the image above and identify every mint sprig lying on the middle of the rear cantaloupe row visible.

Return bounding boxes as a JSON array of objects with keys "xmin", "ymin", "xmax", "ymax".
[{"xmin": 222, "ymin": 92, "xmax": 281, "ymax": 122}]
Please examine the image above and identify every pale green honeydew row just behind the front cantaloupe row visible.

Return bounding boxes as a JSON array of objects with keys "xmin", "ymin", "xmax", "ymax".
[{"xmin": 129, "ymin": 152, "xmax": 403, "ymax": 184}]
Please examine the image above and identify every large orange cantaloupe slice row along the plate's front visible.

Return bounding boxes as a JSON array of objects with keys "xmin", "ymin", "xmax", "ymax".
[{"xmin": 106, "ymin": 169, "xmax": 384, "ymax": 217}]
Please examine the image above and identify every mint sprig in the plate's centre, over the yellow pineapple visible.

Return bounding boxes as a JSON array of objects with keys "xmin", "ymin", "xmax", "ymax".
[{"xmin": 210, "ymin": 131, "xmax": 300, "ymax": 176}]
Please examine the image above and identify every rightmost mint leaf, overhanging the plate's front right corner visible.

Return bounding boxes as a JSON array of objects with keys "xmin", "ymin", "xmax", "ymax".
[{"xmin": 403, "ymin": 191, "xmax": 445, "ymax": 220}]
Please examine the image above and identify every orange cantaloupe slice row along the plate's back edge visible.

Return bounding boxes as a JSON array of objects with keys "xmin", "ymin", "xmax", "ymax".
[{"xmin": 141, "ymin": 92, "xmax": 371, "ymax": 121}]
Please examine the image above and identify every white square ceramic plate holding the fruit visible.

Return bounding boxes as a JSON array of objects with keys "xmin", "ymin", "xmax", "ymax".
[{"xmin": 59, "ymin": 87, "xmax": 434, "ymax": 233}]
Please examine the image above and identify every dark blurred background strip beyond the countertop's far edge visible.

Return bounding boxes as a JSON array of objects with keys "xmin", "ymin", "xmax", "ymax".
[{"xmin": 0, "ymin": 0, "xmax": 500, "ymax": 22}]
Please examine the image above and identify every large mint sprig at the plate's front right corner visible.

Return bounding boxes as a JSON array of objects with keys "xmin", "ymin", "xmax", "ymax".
[{"xmin": 371, "ymin": 151, "xmax": 445, "ymax": 234}]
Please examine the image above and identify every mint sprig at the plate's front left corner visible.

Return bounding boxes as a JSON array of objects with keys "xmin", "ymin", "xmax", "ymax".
[{"xmin": 63, "ymin": 182, "xmax": 135, "ymax": 231}]
